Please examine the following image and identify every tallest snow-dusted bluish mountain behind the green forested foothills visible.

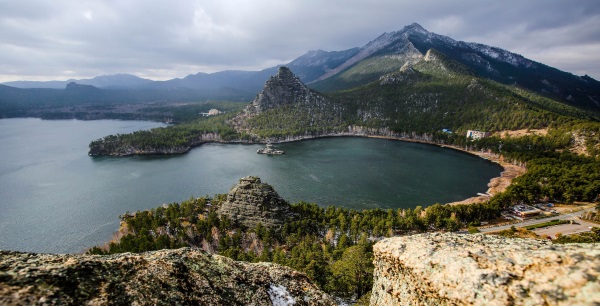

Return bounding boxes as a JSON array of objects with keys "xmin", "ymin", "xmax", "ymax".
[{"xmin": 311, "ymin": 23, "xmax": 600, "ymax": 112}]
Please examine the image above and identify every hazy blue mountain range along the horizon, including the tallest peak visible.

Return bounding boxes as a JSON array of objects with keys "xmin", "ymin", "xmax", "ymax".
[{"xmin": 0, "ymin": 23, "xmax": 600, "ymax": 113}]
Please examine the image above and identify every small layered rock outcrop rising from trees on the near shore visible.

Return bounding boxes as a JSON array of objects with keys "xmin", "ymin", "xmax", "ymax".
[{"xmin": 218, "ymin": 176, "xmax": 292, "ymax": 228}]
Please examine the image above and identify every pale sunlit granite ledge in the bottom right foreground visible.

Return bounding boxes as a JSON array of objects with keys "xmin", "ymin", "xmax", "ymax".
[{"xmin": 371, "ymin": 233, "xmax": 600, "ymax": 305}]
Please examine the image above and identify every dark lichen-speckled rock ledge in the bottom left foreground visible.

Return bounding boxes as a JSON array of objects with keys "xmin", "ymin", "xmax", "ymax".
[{"xmin": 0, "ymin": 248, "xmax": 335, "ymax": 305}]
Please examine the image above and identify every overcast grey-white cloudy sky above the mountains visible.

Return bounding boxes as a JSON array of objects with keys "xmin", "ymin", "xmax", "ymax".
[{"xmin": 0, "ymin": 0, "xmax": 600, "ymax": 82}]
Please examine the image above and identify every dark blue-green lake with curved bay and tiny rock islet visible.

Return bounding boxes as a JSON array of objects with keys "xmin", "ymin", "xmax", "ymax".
[{"xmin": 0, "ymin": 118, "xmax": 502, "ymax": 253}]
